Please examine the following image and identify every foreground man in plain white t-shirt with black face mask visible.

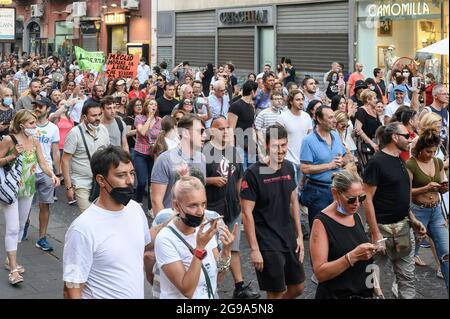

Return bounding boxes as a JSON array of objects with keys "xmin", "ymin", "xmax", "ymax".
[{"xmin": 63, "ymin": 145, "xmax": 151, "ymax": 299}]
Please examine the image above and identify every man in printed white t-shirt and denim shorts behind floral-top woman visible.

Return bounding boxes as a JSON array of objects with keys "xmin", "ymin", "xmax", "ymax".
[{"xmin": 33, "ymin": 100, "xmax": 61, "ymax": 251}]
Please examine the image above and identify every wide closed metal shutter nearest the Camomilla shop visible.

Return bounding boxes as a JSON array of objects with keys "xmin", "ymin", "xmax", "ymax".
[{"xmin": 277, "ymin": 2, "xmax": 349, "ymax": 75}]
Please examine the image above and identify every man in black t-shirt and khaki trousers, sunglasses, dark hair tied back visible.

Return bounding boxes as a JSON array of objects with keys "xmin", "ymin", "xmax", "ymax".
[{"xmin": 364, "ymin": 122, "xmax": 427, "ymax": 299}]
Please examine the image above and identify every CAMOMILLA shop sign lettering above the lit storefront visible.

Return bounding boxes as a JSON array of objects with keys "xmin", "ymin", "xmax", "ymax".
[{"xmin": 367, "ymin": 1, "xmax": 430, "ymax": 18}]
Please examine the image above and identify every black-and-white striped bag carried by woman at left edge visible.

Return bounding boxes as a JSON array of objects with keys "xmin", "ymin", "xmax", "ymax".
[{"xmin": 0, "ymin": 135, "xmax": 22, "ymax": 205}]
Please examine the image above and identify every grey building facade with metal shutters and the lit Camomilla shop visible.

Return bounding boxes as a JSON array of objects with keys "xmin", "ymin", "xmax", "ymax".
[{"xmin": 152, "ymin": 0, "xmax": 448, "ymax": 82}]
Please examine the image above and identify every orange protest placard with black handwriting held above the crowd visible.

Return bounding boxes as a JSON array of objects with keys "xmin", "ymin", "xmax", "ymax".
[{"xmin": 105, "ymin": 53, "xmax": 139, "ymax": 79}]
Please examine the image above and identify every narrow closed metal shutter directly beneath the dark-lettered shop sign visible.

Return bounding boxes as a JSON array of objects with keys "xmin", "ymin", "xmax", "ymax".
[{"xmin": 218, "ymin": 28, "xmax": 255, "ymax": 74}]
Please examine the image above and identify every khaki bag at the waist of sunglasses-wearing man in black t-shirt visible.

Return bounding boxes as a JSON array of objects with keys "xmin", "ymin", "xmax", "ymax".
[{"xmin": 378, "ymin": 217, "xmax": 412, "ymax": 260}]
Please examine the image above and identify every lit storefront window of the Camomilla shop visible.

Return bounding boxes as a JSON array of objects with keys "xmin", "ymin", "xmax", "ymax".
[{"xmin": 356, "ymin": 0, "xmax": 448, "ymax": 82}]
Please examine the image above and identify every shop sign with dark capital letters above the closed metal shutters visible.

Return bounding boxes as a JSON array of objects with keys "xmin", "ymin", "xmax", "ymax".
[{"xmin": 217, "ymin": 7, "xmax": 273, "ymax": 27}]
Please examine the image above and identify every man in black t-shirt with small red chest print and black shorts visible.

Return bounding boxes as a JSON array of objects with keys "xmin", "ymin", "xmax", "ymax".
[{"xmin": 241, "ymin": 125, "xmax": 305, "ymax": 299}]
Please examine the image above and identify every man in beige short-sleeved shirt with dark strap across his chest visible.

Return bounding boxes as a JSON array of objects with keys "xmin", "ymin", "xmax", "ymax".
[{"xmin": 62, "ymin": 104, "xmax": 110, "ymax": 212}]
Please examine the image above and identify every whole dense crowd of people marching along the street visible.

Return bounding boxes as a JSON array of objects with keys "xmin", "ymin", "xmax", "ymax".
[{"xmin": 0, "ymin": 55, "xmax": 449, "ymax": 299}]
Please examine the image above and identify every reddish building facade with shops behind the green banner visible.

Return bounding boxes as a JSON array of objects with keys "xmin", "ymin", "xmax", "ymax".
[{"xmin": 0, "ymin": 0, "xmax": 151, "ymax": 59}]
